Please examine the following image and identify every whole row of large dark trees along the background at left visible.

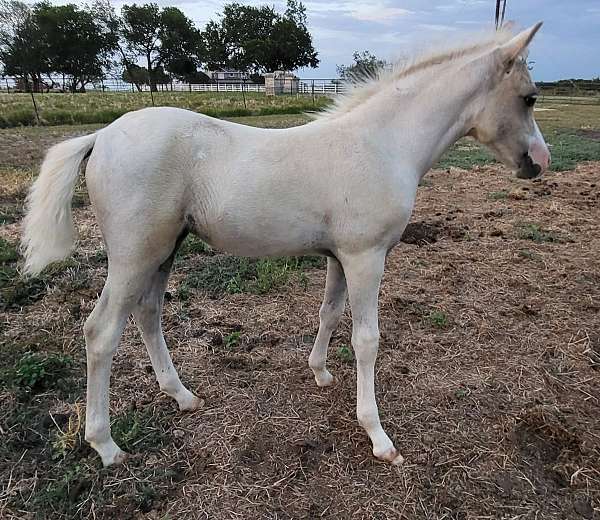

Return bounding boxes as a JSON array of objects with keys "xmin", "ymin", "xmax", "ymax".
[{"xmin": 0, "ymin": 0, "xmax": 319, "ymax": 92}]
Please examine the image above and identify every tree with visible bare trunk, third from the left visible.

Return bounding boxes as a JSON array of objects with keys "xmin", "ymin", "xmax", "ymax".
[{"xmin": 121, "ymin": 4, "xmax": 202, "ymax": 90}]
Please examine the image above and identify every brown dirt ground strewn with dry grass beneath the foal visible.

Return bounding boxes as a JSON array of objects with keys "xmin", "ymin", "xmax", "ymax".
[{"xmin": 0, "ymin": 125, "xmax": 600, "ymax": 520}]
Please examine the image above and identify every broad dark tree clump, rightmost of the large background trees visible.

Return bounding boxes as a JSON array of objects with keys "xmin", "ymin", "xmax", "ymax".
[{"xmin": 203, "ymin": 0, "xmax": 319, "ymax": 74}]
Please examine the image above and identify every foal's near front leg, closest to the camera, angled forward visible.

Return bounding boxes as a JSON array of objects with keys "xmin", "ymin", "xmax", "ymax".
[{"xmin": 342, "ymin": 251, "xmax": 404, "ymax": 464}]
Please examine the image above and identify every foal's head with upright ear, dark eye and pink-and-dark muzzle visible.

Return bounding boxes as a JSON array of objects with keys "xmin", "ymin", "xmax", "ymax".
[{"xmin": 469, "ymin": 22, "xmax": 550, "ymax": 179}]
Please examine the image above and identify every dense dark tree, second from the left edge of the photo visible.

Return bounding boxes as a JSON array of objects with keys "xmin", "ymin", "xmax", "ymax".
[{"xmin": 33, "ymin": 2, "xmax": 117, "ymax": 92}]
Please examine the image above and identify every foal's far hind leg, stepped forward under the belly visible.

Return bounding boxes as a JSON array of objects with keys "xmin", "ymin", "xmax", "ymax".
[{"xmin": 133, "ymin": 253, "xmax": 201, "ymax": 410}]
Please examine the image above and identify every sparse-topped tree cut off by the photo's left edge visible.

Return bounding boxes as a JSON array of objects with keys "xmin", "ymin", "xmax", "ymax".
[{"xmin": 0, "ymin": 0, "xmax": 48, "ymax": 92}]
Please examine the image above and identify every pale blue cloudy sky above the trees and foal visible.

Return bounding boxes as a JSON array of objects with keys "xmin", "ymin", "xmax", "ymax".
[{"xmin": 50, "ymin": 0, "xmax": 600, "ymax": 81}]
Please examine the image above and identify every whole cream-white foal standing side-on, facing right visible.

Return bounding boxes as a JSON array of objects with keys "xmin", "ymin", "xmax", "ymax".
[{"xmin": 23, "ymin": 23, "xmax": 550, "ymax": 465}]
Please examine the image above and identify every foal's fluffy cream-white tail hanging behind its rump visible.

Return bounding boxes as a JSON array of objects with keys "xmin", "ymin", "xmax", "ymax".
[{"xmin": 21, "ymin": 134, "xmax": 96, "ymax": 275}]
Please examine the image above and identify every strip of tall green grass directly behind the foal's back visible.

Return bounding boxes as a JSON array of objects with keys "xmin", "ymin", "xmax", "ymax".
[{"xmin": 0, "ymin": 92, "xmax": 331, "ymax": 128}]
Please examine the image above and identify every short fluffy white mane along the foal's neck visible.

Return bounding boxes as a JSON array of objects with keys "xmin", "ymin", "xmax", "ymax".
[{"xmin": 315, "ymin": 27, "xmax": 513, "ymax": 119}]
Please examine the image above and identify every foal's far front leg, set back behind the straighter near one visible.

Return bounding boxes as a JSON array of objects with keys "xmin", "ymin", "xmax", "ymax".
[{"xmin": 308, "ymin": 258, "xmax": 347, "ymax": 386}]
